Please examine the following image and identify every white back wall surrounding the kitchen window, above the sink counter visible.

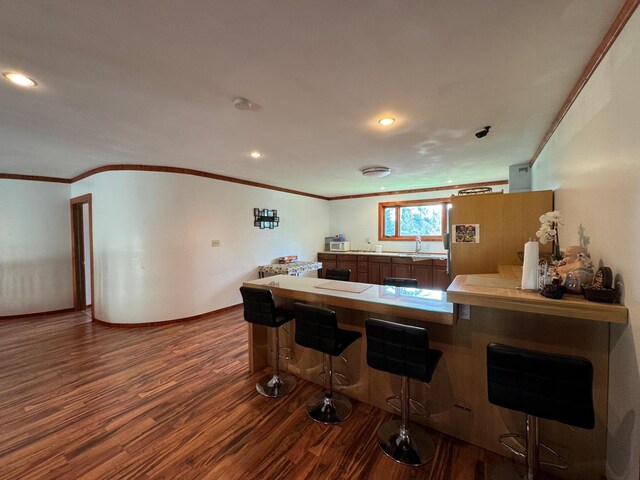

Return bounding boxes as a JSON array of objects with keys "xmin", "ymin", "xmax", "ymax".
[{"xmin": 326, "ymin": 183, "xmax": 509, "ymax": 252}]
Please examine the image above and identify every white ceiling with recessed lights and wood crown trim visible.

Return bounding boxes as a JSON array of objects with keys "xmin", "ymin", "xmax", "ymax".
[{"xmin": 0, "ymin": 0, "xmax": 624, "ymax": 196}]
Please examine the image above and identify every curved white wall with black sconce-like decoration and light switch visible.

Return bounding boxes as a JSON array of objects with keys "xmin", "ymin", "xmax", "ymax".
[{"xmin": 71, "ymin": 171, "xmax": 329, "ymax": 323}]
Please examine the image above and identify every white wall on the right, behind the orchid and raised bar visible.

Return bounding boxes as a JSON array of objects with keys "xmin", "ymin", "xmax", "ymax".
[{"xmin": 532, "ymin": 11, "xmax": 640, "ymax": 480}]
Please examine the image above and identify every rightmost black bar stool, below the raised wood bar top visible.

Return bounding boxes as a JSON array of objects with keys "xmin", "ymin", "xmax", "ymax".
[{"xmin": 487, "ymin": 343, "xmax": 595, "ymax": 480}]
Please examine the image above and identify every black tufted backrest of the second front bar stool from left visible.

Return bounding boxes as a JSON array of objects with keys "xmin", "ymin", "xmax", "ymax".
[{"xmin": 293, "ymin": 303, "xmax": 339, "ymax": 355}]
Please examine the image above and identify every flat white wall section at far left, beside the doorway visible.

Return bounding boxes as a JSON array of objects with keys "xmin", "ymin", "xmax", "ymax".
[{"xmin": 0, "ymin": 180, "xmax": 73, "ymax": 316}]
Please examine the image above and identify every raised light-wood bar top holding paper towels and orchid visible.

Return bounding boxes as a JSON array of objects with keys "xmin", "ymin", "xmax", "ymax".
[{"xmin": 447, "ymin": 266, "xmax": 629, "ymax": 325}]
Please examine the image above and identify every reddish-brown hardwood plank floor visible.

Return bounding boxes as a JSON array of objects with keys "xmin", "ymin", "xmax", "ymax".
[{"xmin": 0, "ymin": 309, "xmax": 504, "ymax": 480}]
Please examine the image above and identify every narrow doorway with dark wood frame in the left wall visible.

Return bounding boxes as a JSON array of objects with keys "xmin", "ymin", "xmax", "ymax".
[{"xmin": 71, "ymin": 193, "xmax": 95, "ymax": 318}]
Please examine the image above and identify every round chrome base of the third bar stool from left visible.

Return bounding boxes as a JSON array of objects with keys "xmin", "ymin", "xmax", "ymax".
[{"xmin": 377, "ymin": 420, "xmax": 436, "ymax": 466}]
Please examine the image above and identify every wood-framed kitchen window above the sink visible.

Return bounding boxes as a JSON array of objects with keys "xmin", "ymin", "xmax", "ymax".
[{"xmin": 378, "ymin": 198, "xmax": 451, "ymax": 241}]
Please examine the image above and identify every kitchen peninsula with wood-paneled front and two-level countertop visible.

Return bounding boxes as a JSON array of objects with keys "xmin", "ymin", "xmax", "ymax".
[{"xmin": 244, "ymin": 270, "xmax": 626, "ymax": 480}]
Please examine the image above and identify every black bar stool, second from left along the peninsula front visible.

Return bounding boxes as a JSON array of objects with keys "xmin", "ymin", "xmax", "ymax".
[{"xmin": 293, "ymin": 303, "xmax": 362, "ymax": 424}]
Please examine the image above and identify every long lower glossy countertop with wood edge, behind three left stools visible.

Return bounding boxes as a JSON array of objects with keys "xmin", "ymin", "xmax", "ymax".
[{"xmin": 244, "ymin": 275, "xmax": 453, "ymax": 325}]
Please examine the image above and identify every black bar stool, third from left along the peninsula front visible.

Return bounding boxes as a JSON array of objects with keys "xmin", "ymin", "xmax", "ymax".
[{"xmin": 365, "ymin": 319, "xmax": 442, "ymax": 465}]
